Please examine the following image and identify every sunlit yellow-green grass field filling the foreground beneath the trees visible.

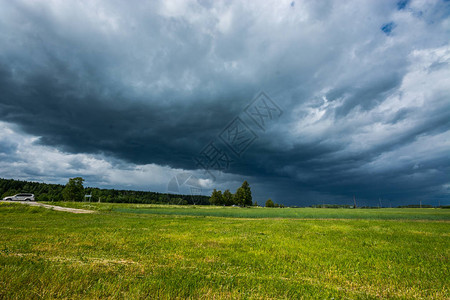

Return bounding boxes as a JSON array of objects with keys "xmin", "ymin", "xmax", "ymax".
[{"xmin": 0, "ymin": 203, "xmax": 450, "ymax": 299}]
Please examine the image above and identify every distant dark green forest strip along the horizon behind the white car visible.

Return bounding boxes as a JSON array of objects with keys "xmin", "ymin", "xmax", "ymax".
[{"xmin": 0, "ymin": 178, "xmax": 210, "ymax": 205}]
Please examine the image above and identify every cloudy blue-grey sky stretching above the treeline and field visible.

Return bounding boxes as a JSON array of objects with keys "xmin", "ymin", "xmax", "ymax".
[{"xmin": 0, "ymin": 0, "xmax": 450, "ymax": 206}]
